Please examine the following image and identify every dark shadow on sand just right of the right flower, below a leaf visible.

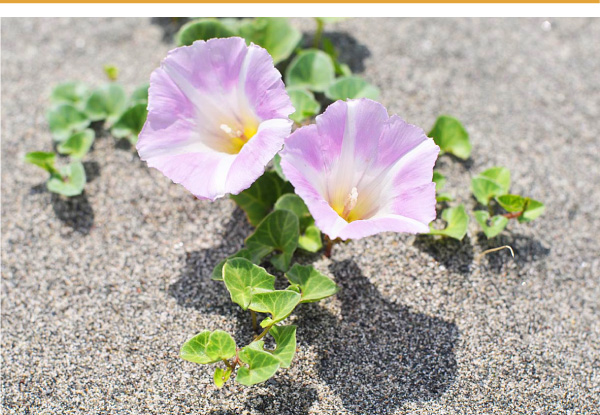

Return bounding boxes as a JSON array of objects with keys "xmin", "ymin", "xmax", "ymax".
[{"xmin": 414, "ymin": 235, "xmax": 474, "ymax": 276}]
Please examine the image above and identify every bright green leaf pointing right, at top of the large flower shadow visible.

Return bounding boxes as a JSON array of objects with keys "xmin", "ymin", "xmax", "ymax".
[{"xmin": 285, "ymin": 264, "xmax": 339, "ymax": 303}]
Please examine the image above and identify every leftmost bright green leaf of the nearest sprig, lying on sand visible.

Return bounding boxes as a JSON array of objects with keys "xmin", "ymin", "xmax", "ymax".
[{"xmin": 179, "ymin": 330, "xmax": 236, "ymax": 364}]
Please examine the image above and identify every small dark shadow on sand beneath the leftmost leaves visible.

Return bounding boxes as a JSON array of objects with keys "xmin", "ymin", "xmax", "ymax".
[{"xmin": 50, "ymin": 192, "xmax": 94, "ymax": 235}]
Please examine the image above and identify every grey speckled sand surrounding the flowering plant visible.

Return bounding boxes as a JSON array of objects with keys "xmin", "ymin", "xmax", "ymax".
[{"xmin": 2, "ymin": 18, "xmax": 600, "ymax": 415}]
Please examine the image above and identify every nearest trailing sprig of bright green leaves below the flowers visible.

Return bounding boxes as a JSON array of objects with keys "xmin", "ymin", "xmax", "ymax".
[{"xmin": 180, "ymin": 256, "xmax": 338, "ymax": 387}]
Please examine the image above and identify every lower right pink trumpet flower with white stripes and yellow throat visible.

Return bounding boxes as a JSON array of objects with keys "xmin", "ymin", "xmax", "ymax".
[{"xmin": 281, "ymin": 99, "xmax": 439, "ymax": 240}]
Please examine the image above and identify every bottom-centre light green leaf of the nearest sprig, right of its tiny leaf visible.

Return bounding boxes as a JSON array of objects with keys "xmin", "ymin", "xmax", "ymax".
[{"xmin": 235, "ymin": 340, "xmax": 281, "ymax": 386}]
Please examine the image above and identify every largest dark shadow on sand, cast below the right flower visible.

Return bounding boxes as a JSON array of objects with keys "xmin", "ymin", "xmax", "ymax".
[{"xmin": 298, "ymin": 260, "xmax": 459, "ymax": 414}]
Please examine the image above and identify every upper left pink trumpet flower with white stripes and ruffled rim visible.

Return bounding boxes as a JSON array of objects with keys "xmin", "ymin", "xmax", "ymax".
[{"xmin": 137, "ymin": 37, "xmax": 294, "ymax": 200}]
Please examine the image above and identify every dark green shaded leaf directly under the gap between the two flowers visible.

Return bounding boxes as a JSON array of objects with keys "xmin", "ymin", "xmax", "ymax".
[{"xmin": 231, "ymin": 171, "xmax": 294, "ymax": 226}]
